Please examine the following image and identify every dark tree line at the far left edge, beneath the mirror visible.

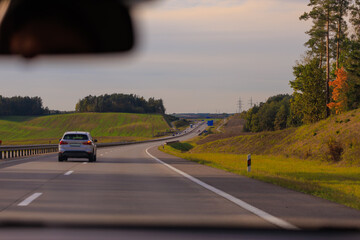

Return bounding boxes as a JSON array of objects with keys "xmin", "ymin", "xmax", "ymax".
[{"xmin": 0, "ymin": 95, "xmax": 49, "ymax": 116}]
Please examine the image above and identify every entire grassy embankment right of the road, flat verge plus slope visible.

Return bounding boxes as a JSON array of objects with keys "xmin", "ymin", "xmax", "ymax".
[{"xmin": 165, "ymin": 110, "xmax": 360, "ymax": 210}]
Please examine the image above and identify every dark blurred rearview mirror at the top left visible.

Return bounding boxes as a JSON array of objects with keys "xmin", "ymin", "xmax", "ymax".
[{"xmin": 0, "ymin": 0, "xmax": 148, "ymax": 58}]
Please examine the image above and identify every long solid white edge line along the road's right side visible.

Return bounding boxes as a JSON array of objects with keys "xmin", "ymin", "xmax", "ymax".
[{"xmin": 146, "ymin": 147, "xmax": 300, "ymax": 230}]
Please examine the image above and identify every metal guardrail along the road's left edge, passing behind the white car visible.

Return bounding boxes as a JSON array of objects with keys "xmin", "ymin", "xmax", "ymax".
[{"xmin": 0, "ymin": 124, "xmax": 202, "ymax": 160}]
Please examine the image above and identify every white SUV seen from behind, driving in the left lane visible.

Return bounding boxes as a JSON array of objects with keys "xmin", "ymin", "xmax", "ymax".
[{"xmin": 59, "ymin": 132, "xmax": 97, "ymax": 162}]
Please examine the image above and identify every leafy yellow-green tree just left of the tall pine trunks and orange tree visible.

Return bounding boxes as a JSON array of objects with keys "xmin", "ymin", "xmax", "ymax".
[{"xmin": 290, "ymin": 59, "xmax": 327, "ymax": 123}]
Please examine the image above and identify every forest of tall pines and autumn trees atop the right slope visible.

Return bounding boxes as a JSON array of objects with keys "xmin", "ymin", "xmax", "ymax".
[{"xmin": 243, "ymin": 0, "xmax": 360, "ymax": 132}]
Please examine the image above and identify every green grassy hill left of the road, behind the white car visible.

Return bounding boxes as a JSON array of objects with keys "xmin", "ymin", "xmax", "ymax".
[{"xmin": 0, "ymin": 113, "xmax": 170, "ymax": 145}]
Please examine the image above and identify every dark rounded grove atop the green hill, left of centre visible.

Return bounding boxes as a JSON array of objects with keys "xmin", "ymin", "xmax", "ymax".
[{"xmin": 75, "ymin": 93, "xmax": 165, "ymax": 114}]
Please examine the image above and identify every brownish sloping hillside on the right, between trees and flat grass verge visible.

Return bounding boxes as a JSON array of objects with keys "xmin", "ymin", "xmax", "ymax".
[{"xmin": 191, "ymin": 109, "xmax": 360, "ymax": 164}]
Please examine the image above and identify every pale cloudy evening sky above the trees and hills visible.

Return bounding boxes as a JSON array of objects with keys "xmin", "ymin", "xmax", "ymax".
[{"xmin": 0, "ymin": 0, "xmax": 310, "ymax": 114}]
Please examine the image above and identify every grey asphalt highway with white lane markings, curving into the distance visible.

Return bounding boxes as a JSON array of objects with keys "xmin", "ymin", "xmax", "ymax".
[{"xmin": 0, "ymin": 124, "xmax": 360, "ymax": 239}]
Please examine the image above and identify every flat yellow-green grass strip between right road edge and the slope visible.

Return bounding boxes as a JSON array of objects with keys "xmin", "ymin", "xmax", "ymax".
[{"xmin": 159, "ymin": 143, "xmax": 360, "ymax": 210}]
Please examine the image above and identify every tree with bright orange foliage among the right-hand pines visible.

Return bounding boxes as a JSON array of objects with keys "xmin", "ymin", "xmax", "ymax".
[{"xmin": 327, "ymin": 67, "xmax": 348, "ymax": 114}]
